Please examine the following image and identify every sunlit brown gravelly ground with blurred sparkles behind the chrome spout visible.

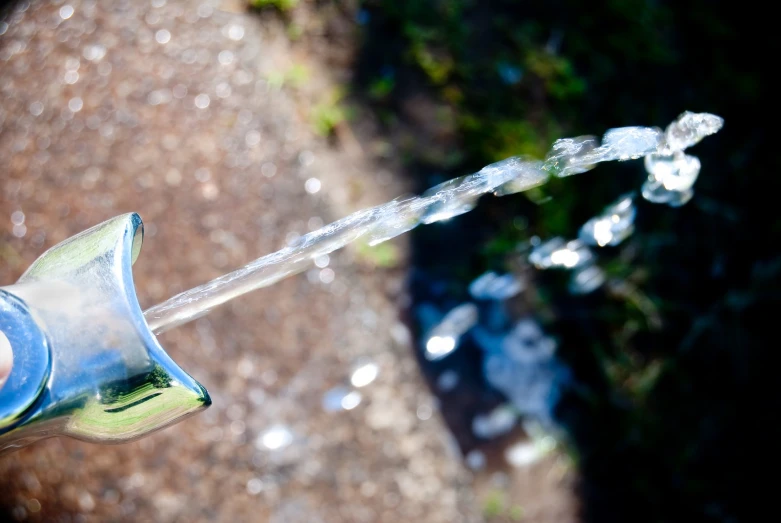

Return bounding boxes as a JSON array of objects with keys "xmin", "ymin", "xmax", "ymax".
[{"xmin": 0, "ymin": 0, "xmax": 577, "ymax": 522}]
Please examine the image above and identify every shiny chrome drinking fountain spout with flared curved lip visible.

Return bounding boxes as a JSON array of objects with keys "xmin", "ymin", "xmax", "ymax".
[{"xmin": 0, "ymin": 213, "xmax": 211, "ymax": 453}]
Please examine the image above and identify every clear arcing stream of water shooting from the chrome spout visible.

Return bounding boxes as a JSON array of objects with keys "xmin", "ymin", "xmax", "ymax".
[{"xmin": 144, "ymin": 112, "xmax": 723, "ymax": 334}]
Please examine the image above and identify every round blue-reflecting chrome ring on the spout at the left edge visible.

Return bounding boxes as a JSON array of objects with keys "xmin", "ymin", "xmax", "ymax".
[{"xmin": 0, "ymin": 289, "xmax": 52, "ymax": 434}]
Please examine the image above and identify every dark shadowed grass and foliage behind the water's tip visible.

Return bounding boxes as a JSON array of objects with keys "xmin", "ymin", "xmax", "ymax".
[{"xmin": 354, "ymin": 0, "xmax": 781, "ymax": 522}]
